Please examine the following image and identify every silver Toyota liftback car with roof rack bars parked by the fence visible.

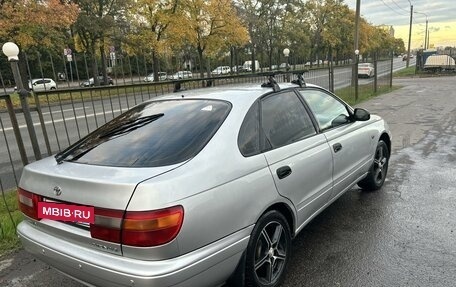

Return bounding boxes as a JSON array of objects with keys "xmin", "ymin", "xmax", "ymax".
[{"xmin": 18, "ymin": 78, "xmax": 391, "ymax": 287}]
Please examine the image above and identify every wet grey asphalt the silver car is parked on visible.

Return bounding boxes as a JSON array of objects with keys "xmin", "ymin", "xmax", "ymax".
[{"xmin": 0, "ymin": 76, "xmax": 456, "ymax": 287}]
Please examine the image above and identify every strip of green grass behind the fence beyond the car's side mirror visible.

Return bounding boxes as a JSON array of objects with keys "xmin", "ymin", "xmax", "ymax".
[{"xmin": 335, "ymin": 85, "xmax": 400, "ymax": 106}]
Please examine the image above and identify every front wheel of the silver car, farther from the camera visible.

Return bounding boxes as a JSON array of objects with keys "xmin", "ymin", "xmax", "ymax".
[{"xmin": 358, "ymin": 140, "xmax": 390, "ymax": 190}]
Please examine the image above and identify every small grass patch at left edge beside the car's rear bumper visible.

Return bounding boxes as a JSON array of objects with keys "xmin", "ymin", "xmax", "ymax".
[{"xmin": 0, "ymin": 190, "xmax": 23, "ymax": 256}]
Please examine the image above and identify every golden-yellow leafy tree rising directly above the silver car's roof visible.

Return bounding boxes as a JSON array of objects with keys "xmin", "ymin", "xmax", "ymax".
[{"xmin": 180, "ymin": 0, "xmax": 249, "ymax": 77}]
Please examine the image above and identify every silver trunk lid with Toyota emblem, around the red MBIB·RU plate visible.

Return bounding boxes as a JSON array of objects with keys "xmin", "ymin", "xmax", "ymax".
[{"xmin": 19, "ymin": 157, "xmax": 179, "ymax": 255}]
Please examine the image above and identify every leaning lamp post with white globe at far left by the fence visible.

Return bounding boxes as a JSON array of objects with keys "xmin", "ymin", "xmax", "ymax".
[{"xmin": 2, "ymin": 42, "xmax": 41, "ymax": 160}]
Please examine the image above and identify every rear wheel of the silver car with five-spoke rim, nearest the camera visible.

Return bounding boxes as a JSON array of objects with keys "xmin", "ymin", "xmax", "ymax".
[{"xmin": 244, "ymin": 210, "xmax": 291, "ymax": 287}]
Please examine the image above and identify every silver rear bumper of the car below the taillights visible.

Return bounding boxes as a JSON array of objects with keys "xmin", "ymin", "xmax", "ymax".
[{"xmin": 18, "ymin": 220, "xmax": 251, "ymax": 287}]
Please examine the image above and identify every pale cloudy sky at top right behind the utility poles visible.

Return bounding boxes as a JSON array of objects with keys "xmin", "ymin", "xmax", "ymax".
[{"xmin": 344, "ymin": 0, "xmax": 456, "ymax": 47}]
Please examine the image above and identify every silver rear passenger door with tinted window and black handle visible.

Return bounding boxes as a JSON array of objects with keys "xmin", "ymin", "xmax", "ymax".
[{"xmin": 260, "ymin": 90, "xmax": 332, "ymax": 228}]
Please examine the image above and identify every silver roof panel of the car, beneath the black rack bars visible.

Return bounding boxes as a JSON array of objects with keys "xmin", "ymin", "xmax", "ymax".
[{"xmin": 157, "ymin": 83, "xmax": 318, "ymax": 105}]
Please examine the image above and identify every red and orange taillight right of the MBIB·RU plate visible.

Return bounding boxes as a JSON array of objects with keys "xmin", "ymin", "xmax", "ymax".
[{"xmin": 90, "ymin": 206, "xmax": 184, "ymax": 247}]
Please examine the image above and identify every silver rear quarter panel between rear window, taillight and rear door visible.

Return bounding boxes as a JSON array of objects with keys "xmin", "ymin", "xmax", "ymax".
[{"xmin": 128, "ymin": 102, "xmax": 292, "ymax": 254}]
